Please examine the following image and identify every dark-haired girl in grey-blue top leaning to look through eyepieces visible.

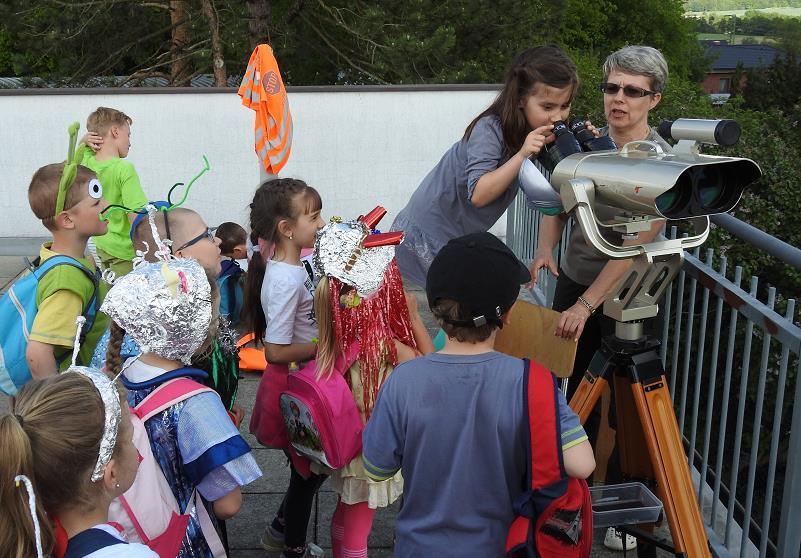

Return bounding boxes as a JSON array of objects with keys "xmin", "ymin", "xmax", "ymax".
[{"xmin": 392, "ymin": 46, "xmax": 579, "ymax": 287}]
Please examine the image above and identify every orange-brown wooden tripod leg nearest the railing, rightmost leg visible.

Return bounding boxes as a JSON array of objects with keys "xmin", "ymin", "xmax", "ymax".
[{"xmin": 618, "ymin": 374, "xmax": 711, "ymax": 558}]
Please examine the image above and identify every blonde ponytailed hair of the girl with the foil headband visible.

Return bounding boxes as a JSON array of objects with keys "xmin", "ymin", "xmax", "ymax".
[{"xmin": 0, "ymin": 372, "xmax": 125, "ymax": 558}]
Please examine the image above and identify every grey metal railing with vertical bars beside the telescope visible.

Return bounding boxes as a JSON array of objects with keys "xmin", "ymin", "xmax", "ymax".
[{"xmin": 506, "ymin": 195, "xmax": 801, "ymax": 558}]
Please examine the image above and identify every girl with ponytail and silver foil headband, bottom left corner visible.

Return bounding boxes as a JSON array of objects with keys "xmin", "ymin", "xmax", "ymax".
[{"xmin": 0, "ymin": 319, "xmax": 152, "ymax": 558}]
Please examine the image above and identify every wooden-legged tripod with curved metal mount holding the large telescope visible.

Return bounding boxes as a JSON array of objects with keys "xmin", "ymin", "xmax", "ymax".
[{"xmin": 561, "ymin": 178, "xmax": 711, "ymax": 558}]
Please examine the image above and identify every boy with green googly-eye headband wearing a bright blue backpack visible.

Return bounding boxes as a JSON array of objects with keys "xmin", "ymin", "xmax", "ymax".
[{"xmin": 0, "ymin": 122, "xmax": 108, "ymax": 396}]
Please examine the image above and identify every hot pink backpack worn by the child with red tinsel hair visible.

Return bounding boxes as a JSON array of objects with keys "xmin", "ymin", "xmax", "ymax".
[{"xmin": 281, "ymin": 343, "xmax": 364, "ymax": 469}]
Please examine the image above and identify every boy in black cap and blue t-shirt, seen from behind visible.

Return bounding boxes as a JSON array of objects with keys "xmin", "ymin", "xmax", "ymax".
[{"xmin": 363, "ymin": 232, "xmax": 595, "ymax": 558}]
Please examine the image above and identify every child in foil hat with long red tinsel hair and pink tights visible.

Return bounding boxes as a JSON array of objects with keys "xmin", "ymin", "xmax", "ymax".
[{"xmin": 312, "ymin": 207, "xmax": 432, "ymax": 558}]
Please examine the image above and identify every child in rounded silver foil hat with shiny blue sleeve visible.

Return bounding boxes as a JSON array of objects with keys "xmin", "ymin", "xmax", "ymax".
[{"xmin": 101, "ymin": 255, "xmax": 261, "ymax": 557}]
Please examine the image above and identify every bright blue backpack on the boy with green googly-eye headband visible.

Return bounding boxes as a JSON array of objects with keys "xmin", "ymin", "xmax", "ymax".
[{"xmin": 0, "ymin": 256, "xmax": 100, "ymax": 396}]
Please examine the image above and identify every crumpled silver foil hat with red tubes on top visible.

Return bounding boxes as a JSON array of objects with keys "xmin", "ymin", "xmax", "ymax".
[{"xmin": 313, "ymin": 206, "xmax": 403, "ymax": 297}]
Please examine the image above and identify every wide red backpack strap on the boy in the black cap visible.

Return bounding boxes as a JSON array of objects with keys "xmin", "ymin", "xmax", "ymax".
[{"xmin": 524, "ymin": 360, "xmax": 566, "ymax": 490}]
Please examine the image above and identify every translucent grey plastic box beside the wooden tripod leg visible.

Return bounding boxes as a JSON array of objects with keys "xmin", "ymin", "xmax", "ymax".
[{"xmin": 590, "ymin": 482, "xmax": 662, "ymax": 527}]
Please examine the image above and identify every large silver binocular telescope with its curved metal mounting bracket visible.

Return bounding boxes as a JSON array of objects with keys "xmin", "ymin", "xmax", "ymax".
[{"xmin": 519, "ymin": 119, "xmax": 762, "ymax": 322}]
